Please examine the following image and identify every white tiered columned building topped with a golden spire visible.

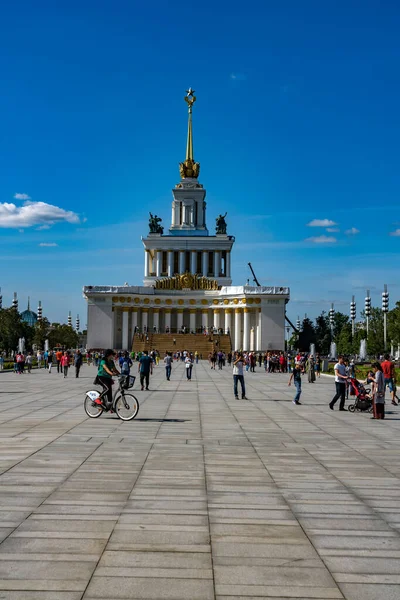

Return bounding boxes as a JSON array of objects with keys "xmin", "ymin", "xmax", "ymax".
[{"xmin": 83, "ymin": 89, "xmax": 289, "ymax": 351}]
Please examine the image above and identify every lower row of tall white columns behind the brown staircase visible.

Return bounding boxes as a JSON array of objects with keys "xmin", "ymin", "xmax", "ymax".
[{"xmin": 114, "ymin": 307, "xmax": 261, "ymax": 350}]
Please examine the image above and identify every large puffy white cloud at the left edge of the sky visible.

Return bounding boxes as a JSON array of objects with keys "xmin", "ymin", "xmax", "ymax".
[{"xmin": 0, "ymin": 201, "xmax": 80, "ymax": 229}]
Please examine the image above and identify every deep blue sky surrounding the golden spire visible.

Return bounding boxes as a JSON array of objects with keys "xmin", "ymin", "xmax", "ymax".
[{"xmin": 0, "ymin": 0, "xmax": 400, "ymax": 325}]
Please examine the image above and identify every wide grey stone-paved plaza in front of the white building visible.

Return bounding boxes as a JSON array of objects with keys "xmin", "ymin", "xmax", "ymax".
[{"xmin": 0, "ymin": 362, "xmax": 400, "ymax": 600}]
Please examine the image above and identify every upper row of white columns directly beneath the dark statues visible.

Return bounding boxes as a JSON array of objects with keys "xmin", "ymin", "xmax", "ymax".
[{"xmin": 144, "ymin": 249, "xmax": 231, "ymax": 278}]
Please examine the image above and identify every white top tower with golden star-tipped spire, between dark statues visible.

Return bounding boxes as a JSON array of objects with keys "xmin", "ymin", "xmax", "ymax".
[{"xmin": 169, "ymin": 88, "xmax": 208, "ymax": 236}]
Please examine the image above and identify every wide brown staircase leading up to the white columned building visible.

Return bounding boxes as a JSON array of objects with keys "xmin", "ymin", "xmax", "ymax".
[{"xmin": 132, "ymin": 333, "xmax": 232, "ymax": 359}]
